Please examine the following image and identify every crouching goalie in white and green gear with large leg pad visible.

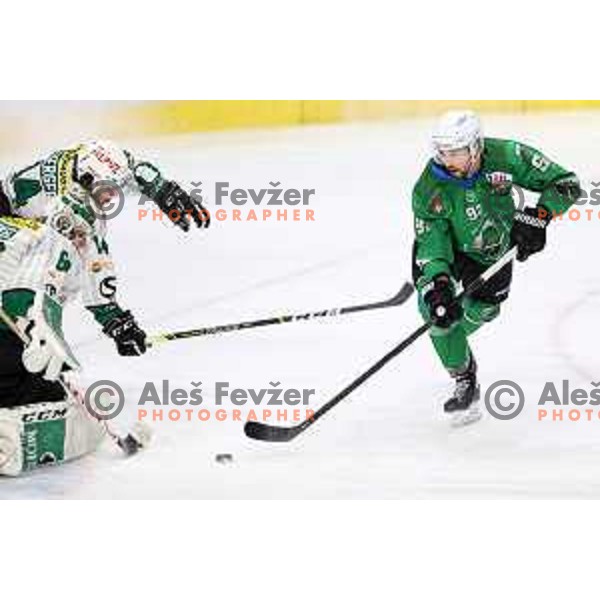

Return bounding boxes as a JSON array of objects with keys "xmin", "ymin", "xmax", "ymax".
[{"xmin": 0, "ymin": 200, "xmax": 152, "ymax": 475}]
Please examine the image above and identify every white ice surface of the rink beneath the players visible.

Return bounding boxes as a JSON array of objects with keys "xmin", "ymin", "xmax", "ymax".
[{"xmin": 0, "ymin": 113, "xmax": 600, "ymax": 499}]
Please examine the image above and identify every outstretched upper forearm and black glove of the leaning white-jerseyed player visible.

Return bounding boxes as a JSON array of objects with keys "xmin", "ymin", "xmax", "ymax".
[{"xmin": 134, "ymin": 163, "xmax": 210, "ymax": 231}]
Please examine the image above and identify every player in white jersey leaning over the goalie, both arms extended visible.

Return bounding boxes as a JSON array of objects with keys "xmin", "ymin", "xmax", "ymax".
[{"xmin": 0, "ymin": 140, "xmax": 210, "ymax": 356}]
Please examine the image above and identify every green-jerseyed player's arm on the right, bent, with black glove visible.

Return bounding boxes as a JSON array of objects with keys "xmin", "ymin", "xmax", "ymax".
[{"xmin": 505, "ymin": 142, "xmax": 581, "ymax": 261}]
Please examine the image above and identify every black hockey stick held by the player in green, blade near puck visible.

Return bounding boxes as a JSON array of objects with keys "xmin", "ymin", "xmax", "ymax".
[{"xmin": 244, "ymin": 248, "xmax": 517, "ymax": 442}]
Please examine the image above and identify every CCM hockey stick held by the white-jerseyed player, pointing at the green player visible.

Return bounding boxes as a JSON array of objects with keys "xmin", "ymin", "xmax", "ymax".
[{"xmin": 148, "ymin": 283, "xmax": 414, "ymax": 346}]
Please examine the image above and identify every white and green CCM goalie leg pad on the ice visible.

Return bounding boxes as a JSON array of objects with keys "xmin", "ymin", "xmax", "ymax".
[{"xmin": 0, "ymin": 400, "xmax": 106, "ymax": 477}]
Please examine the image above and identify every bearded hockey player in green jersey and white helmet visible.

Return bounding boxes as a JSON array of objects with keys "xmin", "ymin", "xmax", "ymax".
[{"xmin": 412, "ymin": 111, "xmax": 581, "ymax": 424}]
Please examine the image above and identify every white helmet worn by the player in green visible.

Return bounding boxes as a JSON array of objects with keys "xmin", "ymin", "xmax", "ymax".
[{"xmin": 431, "ymin": 110, "xmax": 483, "ymax": 163}]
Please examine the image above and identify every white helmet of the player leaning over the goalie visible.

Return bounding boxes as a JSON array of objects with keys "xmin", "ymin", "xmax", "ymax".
[{"xmin": 74, "ymin": 140, "xmax": 132, "ymax": 191}]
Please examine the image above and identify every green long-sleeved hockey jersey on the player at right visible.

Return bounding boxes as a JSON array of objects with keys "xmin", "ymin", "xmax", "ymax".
[{"xmin": 412, "ymin": 138, "xmax": 576, "ymax": 287}]
